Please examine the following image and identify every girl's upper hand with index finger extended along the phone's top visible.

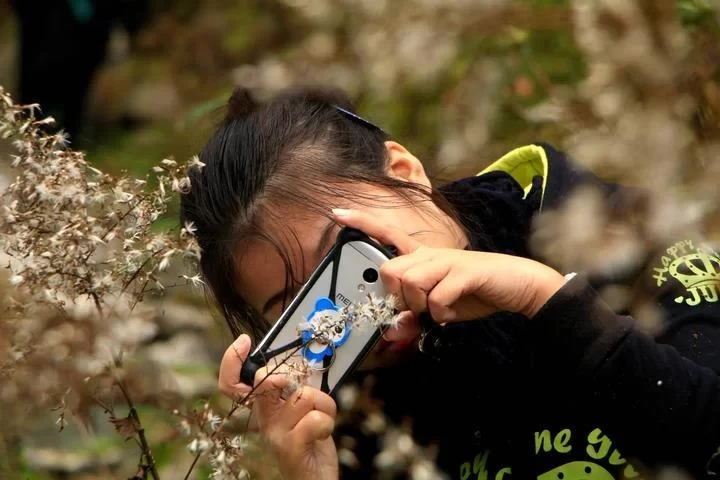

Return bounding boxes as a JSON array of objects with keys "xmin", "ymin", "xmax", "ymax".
[{"xmin": 333, "ymin": 210, "xmax": 565, "ymax": 340}]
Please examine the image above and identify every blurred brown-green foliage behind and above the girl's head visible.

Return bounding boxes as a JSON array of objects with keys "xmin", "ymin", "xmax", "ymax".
[{"xmin": 0, "ymin": 0, "xmax": 718, "ymax": 180}]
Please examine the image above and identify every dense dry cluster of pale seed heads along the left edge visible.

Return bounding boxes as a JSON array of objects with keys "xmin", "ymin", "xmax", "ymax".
[{"xmin": 0, "ymin": 85, "xmax": 199, "ymax": 397}]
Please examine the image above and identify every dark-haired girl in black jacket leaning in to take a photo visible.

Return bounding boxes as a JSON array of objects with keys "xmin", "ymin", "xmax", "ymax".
[{"xmin": 181, "ymin": 90, "xmax": 720, "ymax": 480}]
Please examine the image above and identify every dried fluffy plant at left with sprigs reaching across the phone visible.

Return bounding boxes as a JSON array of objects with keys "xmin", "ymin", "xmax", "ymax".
[{"xmin": 0, "ymin": 89, "xmax": 410, "ymax": 479}]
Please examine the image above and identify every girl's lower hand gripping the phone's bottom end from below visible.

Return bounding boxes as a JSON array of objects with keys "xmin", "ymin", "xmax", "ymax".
[{"xmin": 218, "ymin": 335, "xmax": 339, "ymax": 480}]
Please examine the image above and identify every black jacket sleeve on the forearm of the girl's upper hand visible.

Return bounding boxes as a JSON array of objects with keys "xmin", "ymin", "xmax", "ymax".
[{"xmin": 530, "ymin": 276, "xmax": 720, "ymax": 478}]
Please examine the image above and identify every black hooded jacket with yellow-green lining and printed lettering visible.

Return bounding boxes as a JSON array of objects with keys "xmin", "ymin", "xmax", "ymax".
[{"xmin": 338, "ymin": 144, "xmax": 720, "ymax": 480}]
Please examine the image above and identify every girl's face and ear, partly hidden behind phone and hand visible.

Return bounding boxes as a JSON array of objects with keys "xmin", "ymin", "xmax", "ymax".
[{"xmin": 235, "ymin": 142, "xmax": 464, "ymax": 366}]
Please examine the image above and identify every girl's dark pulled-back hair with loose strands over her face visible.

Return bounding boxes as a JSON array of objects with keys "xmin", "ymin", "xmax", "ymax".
[{"xmin": 180, "ymin": 88, "xmax": 462, "ymax": 338}]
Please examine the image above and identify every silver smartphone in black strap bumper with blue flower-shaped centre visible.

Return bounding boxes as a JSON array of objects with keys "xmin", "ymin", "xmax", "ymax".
[{"xmin": 240, "ymin": 228, "xmax": 394, "ymax": 395}]
